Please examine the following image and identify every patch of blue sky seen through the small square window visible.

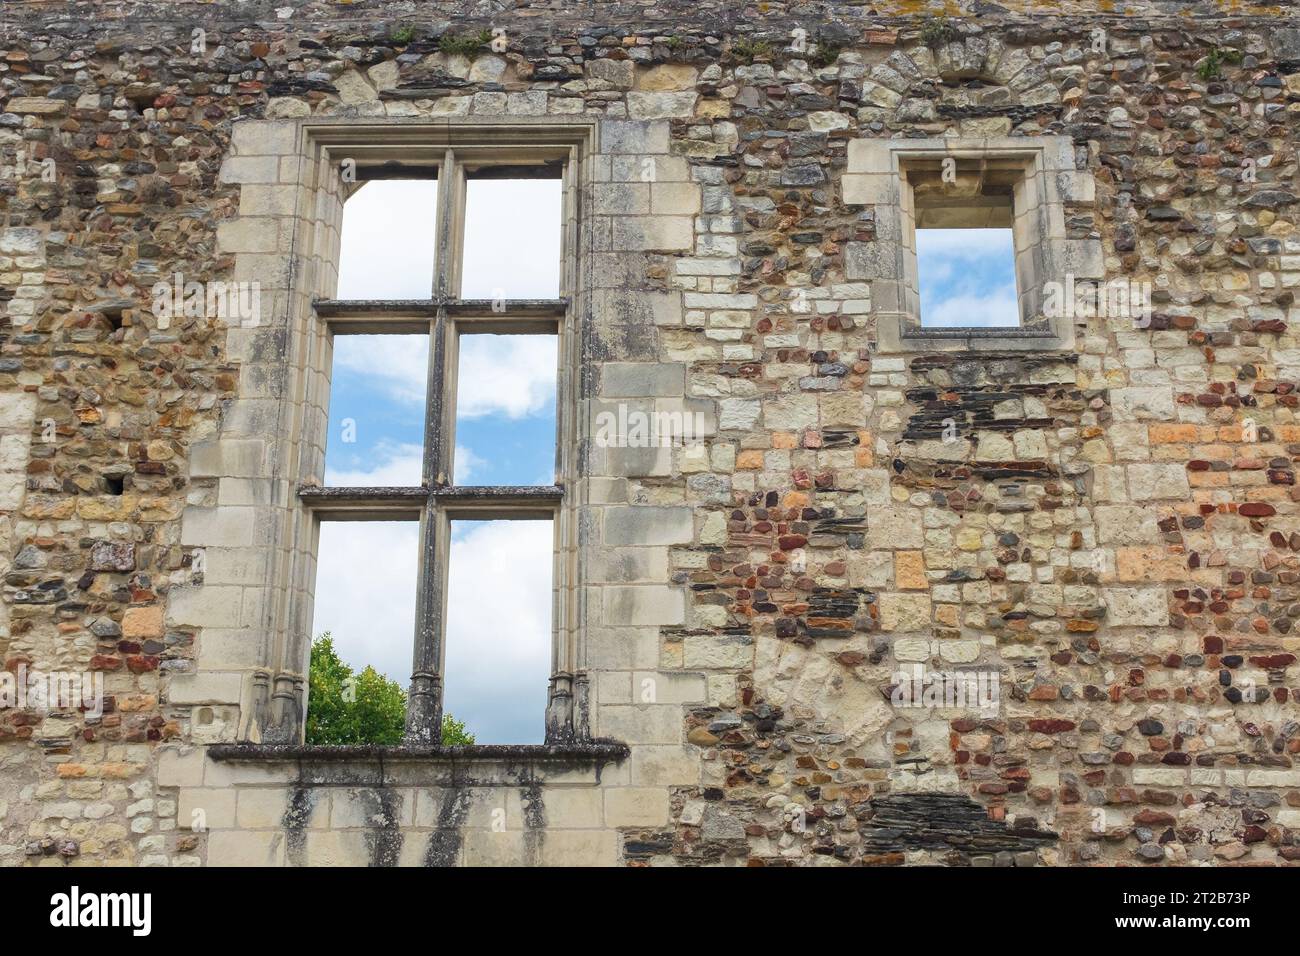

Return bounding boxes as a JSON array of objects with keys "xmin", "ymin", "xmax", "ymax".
[{"xmin": 917, "ymin": 229, "xmax": 1021, "ymax": 328}]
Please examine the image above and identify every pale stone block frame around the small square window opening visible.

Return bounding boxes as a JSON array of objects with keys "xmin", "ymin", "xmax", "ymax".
[{"xmin": 842, "ymin": 137, "xmax": 1104, "ymax": 352}]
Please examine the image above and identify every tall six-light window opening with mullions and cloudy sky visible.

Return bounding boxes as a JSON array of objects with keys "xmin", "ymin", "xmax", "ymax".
[{"xmin": 295, "ymin": 135, "xmax": 586, "ymax": 744}]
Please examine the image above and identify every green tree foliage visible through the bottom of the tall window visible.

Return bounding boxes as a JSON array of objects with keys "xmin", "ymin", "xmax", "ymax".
[{"xmin": 307, "ymin": 631, "xmax": 475, "ymax": 747}]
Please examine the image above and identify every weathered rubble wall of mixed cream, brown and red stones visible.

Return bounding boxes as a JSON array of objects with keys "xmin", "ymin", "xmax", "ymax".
[{"xmin": 0, "ymin": 0, "xmax": 1300, "ymax": 866}]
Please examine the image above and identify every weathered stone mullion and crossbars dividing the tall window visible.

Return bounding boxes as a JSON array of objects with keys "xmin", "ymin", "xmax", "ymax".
[{"xmin": 298, "ymin": 130, "xmax": 585, "ymax": 744}]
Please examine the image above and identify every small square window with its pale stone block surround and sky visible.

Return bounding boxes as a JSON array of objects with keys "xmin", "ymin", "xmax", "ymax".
[{"xmin": 841, "ymin": 135, "xmax": 1086, "ymax": 354}]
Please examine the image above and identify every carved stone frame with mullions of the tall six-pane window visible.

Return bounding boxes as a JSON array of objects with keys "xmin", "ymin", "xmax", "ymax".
[{"xmin": 255, "ymin": 117, "xmax": 595, "ymax": 747}]
